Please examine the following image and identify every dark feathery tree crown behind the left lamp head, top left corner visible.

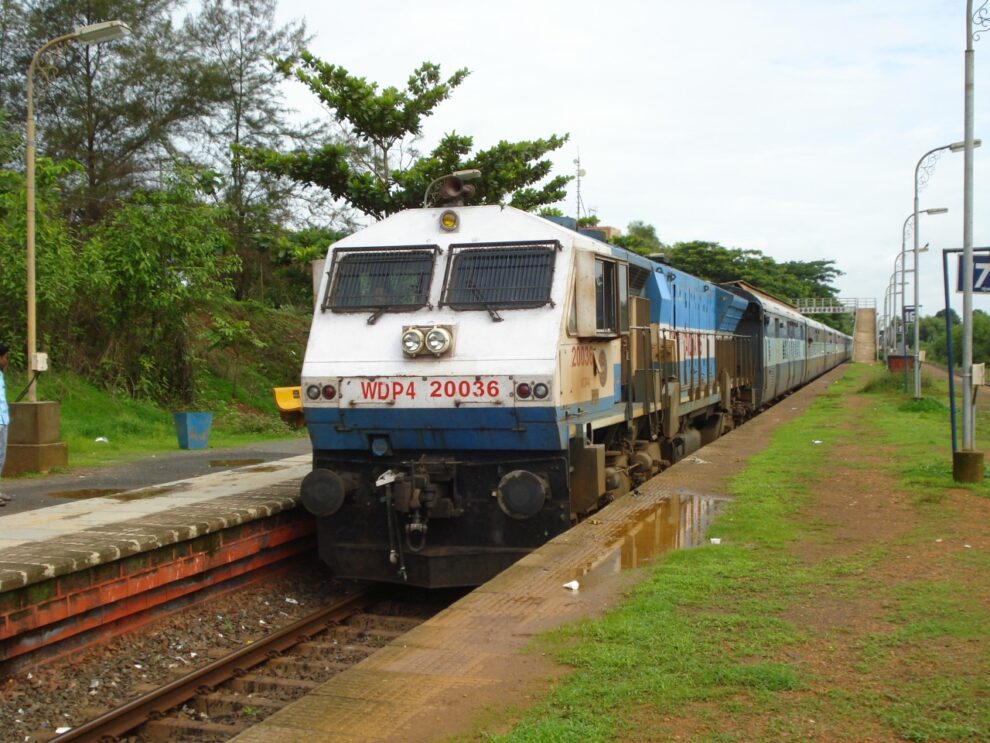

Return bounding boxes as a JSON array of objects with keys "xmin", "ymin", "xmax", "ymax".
[{"xmin": 9, "ymin": 0, "xmax": 229, "ymax": 223}]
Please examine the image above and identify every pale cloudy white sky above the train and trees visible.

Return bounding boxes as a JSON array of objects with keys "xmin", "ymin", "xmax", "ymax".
[{"xmin": 277, "ymin": 0, "xmax": 990, "ymax": 315}]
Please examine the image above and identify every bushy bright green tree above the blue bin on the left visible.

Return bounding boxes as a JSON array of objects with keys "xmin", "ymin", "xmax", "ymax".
[{"xmin": 73, "ymin": 172, "xmax": 237, "ymax": 400}]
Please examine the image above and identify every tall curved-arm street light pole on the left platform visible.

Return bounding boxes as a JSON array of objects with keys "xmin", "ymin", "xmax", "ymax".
[{"xmin": 24, "ymin": 21, "xmax": 130, "ymax": 402}]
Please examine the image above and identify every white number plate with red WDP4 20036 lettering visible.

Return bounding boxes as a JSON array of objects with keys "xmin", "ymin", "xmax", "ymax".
[{"xmin": 340, "ymin": 377, "xmax": 512, "ymax": 408}]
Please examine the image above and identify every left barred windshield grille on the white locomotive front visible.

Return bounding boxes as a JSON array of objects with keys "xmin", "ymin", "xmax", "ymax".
[{"xmin": 323, "ymin": 245, "xmax": 439, "ymax": 312}]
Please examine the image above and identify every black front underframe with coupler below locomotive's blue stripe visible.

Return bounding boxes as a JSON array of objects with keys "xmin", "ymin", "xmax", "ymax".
[{"xmin": 313, "ymin": 451, "xmax": 571, "ymax": 588}]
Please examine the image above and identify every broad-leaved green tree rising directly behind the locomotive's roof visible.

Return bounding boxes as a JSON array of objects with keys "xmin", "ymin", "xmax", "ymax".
[{"xmin": 238, "ymin": 52, "xmax": 570, "ymax": 219}]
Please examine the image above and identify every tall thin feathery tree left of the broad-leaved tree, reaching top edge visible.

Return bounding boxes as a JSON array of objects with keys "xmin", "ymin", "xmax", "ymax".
[{"xmin": 185, "ymin": 0, "xmax": 310, "ymax": 298}]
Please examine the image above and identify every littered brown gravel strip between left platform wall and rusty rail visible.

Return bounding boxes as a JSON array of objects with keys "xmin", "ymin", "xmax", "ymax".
[{"xmin": 0, "ymin": 560, "xmax": 353, "ymax": 743}]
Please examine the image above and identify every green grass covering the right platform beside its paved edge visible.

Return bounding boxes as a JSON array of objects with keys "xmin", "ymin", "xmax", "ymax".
[{"xmin": 473, "ymin": 365, "xmax": 990, "ymax": 742}]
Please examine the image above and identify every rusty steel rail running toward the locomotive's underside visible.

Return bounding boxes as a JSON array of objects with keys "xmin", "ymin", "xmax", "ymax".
[{"xmin": 52, "ymin": 588, "xmax": 376, "ymax": 743}]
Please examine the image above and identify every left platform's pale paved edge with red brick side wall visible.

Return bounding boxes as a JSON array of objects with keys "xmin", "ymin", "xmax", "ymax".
[{"xmin": 0, "ymin": 454, "xmax": 315, "ymax": 667}]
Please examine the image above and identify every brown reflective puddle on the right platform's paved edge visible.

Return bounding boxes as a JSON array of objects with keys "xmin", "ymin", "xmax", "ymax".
[{"xmin": 622, "ymin": 492, "xmax": 732, "ymax": 570}]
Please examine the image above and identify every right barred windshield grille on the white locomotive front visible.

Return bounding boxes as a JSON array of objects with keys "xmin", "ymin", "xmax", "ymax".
[{"xmin": 441, "ymin": 242, "xmax": 560, "ymax": 311}]
